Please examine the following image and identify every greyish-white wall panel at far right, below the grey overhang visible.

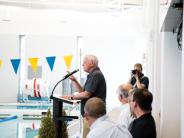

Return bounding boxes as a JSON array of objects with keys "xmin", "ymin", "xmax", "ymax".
[{"xmin": 161, "ymin": 32, "xmax": 182, "ymax": 138}]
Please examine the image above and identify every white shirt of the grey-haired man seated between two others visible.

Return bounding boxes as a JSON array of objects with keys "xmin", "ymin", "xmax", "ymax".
[{"xmin": 117, "ymin": 103, "xmax": 134, "ymax": 129}]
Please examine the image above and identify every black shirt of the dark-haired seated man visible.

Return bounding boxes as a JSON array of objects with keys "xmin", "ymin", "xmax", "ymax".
[{"xmin": 128, "ymin": 113, "xmax": 156, "ymax": 138}]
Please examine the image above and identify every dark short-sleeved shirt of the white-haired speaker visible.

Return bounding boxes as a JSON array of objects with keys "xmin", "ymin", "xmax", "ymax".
[{"xmin": 81, "ymin": 67, "xmax": 106, "ymax": 116}]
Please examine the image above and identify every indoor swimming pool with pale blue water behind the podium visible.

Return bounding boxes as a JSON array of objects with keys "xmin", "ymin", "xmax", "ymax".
[{"xmin": 0, "ymin": 103, "xmax": 80, "ymax": 138}]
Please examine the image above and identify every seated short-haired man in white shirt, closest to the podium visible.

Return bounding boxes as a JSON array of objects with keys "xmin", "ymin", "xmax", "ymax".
[{"xmin": 84, "ymin": 97, "xmax": 132, "ymax": 138}]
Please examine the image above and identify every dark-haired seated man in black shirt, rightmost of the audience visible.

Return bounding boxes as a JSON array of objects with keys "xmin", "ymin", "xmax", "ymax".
[{"xmin": 129, "ymin": 88, "xmax": 156, "ymax": 138}]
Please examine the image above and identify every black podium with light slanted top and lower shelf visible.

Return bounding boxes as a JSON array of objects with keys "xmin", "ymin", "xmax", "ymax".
[{"xmin": 53, "ymin": 96, "xmax": 80, "ymax": 138}]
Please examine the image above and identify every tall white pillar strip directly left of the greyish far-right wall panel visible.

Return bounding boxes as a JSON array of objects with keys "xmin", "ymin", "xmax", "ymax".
[{"xmin": 144, "ymin": 0, "xmax": 161, "ymax": 138}]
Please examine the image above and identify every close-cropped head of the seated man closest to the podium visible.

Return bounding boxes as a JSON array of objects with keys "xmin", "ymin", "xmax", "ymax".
[{"xmin": 84, "ymin": 97, "xmax": 106, "ymax": 118}]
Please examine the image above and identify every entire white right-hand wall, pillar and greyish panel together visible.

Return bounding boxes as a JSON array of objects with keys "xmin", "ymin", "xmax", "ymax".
[{"xmin": 145, "ymin": 0, "xmax": 183, "ymax": 138}]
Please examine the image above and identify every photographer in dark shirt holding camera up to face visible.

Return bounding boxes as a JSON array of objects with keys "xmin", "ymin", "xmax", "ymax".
[{"xmin": 128, "ymin": 63, "xmax": 149, "ymax": 89}]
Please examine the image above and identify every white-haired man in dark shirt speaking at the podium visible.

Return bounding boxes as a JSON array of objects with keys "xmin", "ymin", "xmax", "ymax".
[{"xmin": 63, "ymin": 55, "xmax": 106, "ymax": 138}]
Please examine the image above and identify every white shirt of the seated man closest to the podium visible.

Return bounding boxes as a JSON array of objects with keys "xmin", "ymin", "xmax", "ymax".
[{"xmin": 87, "ymin": 115, "xmax": 132, "ymax": 138}]
